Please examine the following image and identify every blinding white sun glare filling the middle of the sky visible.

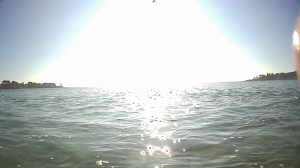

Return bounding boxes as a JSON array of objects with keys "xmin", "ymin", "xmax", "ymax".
[{"xmin": 40, "ymin": 0, "xmax": 261, "ymax": 88}]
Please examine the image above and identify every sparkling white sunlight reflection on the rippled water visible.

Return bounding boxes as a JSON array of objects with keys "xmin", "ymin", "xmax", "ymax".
[{"xmin": 136, "ymin": 86, "xmax": 189, "ymax": 167}]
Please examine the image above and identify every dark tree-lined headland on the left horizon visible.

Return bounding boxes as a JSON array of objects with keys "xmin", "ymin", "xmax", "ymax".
[{"xmin": 0, "ymin": 80, "xmax": 63, "ymax": 89}]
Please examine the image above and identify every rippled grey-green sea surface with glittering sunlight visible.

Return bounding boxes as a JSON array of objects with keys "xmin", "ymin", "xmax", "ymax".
[{"xmin": 0, "ymin": 80, "xmax": 300, "ymax": 168}]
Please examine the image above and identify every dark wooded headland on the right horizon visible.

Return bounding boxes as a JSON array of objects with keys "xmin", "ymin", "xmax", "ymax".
[{"xmin": 246, "ymin": 71, "xmax": 297, "ymax": 81}]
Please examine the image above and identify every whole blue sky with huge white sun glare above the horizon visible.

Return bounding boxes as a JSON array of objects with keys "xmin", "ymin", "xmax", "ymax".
[{"xmin": 0, "ymin": 0, "xmax": 300, "ymax": 86}]
